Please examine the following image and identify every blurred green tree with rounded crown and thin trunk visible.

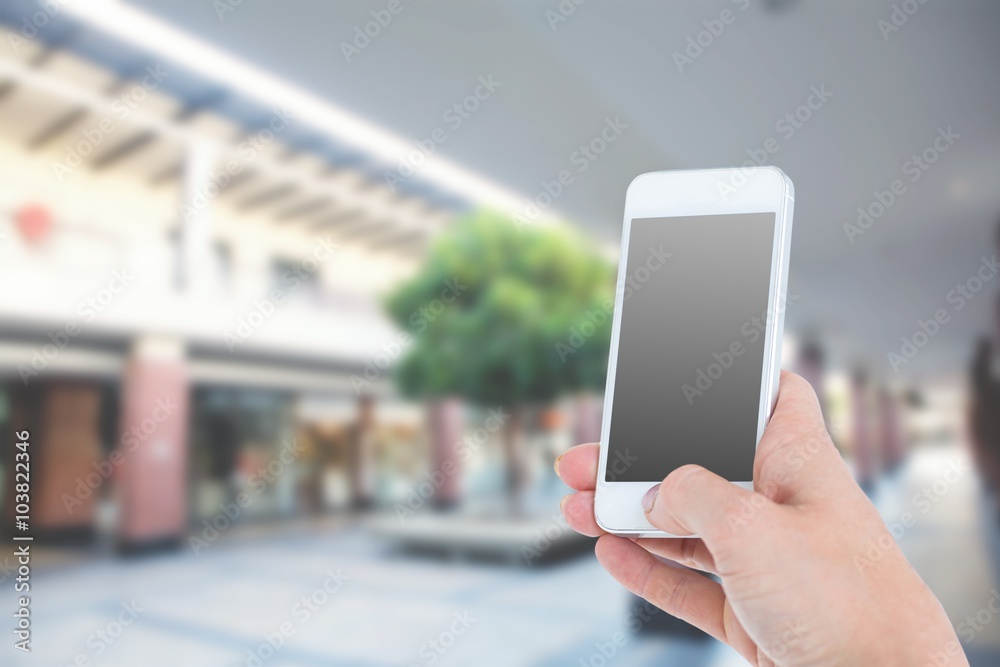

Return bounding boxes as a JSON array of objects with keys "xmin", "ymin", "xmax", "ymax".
[{"xmin": 386, "ymin": 212, "xmax": 614, "ymax": 509}]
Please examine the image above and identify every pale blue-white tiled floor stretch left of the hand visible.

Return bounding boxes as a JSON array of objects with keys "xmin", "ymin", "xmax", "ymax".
[{"xmin": 4, "ymin": 527, "xmax": 739, "ymax": 667}]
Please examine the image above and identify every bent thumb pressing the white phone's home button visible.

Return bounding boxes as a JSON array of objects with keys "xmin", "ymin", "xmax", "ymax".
[{"xmin": 642, "ymin": 465, "xmax": 773, "ymax": 550}]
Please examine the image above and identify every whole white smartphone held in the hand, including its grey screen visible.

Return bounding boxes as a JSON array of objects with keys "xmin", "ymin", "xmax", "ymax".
[{"xmin": 594, "ymin": 167, "xmax": 795, "ymax": 537}]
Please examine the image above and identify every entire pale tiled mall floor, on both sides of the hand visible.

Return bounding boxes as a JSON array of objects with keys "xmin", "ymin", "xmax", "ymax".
[{"xmin": 0, "ymin": 451, "xmax": 1000, "ymax": 667}]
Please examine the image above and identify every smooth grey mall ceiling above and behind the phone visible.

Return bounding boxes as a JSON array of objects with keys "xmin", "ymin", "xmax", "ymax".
[{"xmin": 9, "ymin": 0, "xmax": 1000, "ymax": 373}]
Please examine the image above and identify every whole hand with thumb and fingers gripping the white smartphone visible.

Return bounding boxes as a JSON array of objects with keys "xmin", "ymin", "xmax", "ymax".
[{"xmin": 556, "ymin": 372, "xmax": 968, "ymax": 666}]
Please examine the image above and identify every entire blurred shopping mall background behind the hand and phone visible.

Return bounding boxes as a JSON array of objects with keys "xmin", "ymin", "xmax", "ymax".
[{"xmin": 0, "ymin": 0, "xmax": 1000, "ymax": 667}]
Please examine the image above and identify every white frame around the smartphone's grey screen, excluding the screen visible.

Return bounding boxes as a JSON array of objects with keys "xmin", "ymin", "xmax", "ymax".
[{"xmin": 594, "ymin": 166, "xmax": 795, "ymax": 537}]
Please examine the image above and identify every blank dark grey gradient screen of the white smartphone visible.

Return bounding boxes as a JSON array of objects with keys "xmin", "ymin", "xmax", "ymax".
[{"xmin": 606, "ymin": 213, "xmax": 775, "ymax": 482}]
